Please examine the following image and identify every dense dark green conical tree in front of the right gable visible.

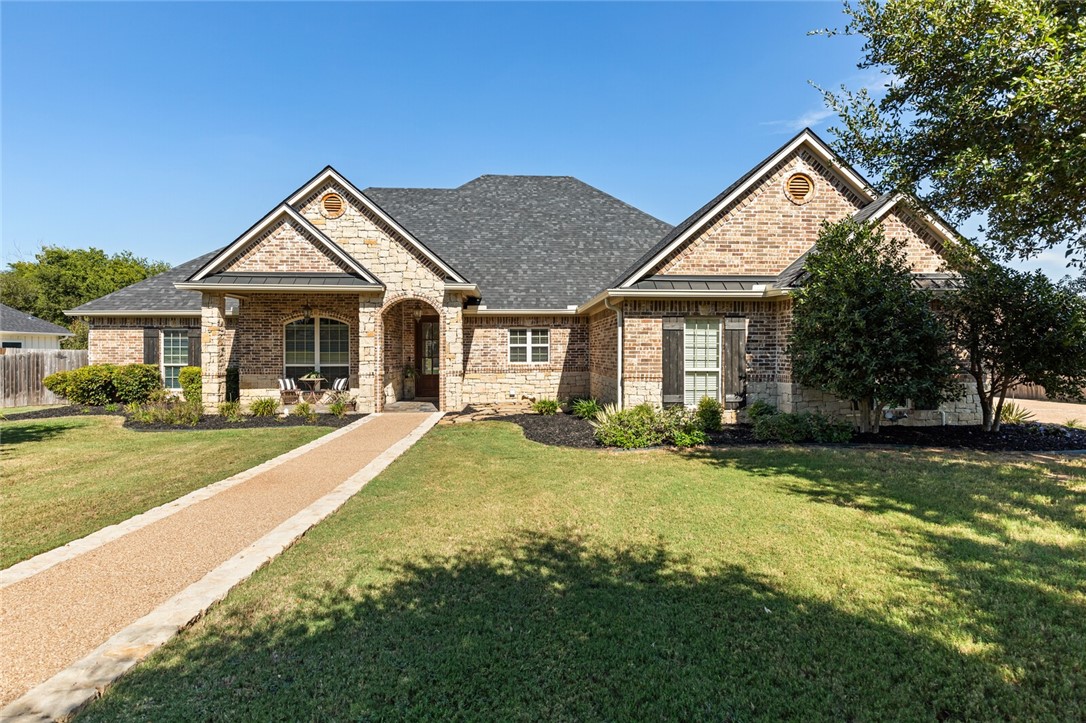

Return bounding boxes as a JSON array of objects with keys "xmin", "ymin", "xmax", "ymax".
[{"xmin": 790, "ymin": 219, "xmax": 961, "ymax": 432}]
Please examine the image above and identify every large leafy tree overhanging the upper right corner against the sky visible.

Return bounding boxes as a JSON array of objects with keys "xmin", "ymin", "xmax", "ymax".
[{"xmin": 824, "ymin": 0, "xmax": 1086, "ymax": 266}]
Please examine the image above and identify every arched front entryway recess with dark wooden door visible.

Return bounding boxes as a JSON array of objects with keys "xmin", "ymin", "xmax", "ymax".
[{"xmin": 378, "ymin": 299, "xmax": 436, "ymax": 409}]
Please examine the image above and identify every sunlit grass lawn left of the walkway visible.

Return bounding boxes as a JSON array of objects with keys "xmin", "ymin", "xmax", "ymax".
[{"xmin": 0, "ymin": 416, "xmax": 330, "ymax": 568}]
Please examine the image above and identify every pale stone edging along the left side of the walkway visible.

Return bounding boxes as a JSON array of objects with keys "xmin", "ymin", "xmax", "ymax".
[{"xmin": 0, "ymin": 415, "xmax": 377, "ymax": 589}]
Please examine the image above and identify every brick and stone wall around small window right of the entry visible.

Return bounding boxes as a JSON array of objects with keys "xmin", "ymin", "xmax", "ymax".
[{"xmin": 462, "ymin": 316, "xmax": 590, "ymax": 404}]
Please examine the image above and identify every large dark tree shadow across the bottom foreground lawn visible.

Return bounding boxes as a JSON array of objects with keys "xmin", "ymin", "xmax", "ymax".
[{"xmin": 82, "ymin": 527, "xmax": 1033, "ymax": 720}]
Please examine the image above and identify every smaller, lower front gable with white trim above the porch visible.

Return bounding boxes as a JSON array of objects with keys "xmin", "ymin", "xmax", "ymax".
[{"xmin": 188, "ymin": 203, "xmax": 380, "ymax": 284}]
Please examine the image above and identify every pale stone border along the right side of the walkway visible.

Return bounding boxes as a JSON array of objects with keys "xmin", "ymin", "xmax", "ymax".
[{"xmin": 0, "ymin": 413, "xmax": 442, "ymax": 723}]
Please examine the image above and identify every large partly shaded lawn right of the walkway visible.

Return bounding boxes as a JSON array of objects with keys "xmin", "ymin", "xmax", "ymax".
[{"xmin": 84, "ymin": 423, "xmax": 1086, "ymax": 721}]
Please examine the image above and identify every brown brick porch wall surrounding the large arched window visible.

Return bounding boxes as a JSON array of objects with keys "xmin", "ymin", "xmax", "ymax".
[{"xmin": 233, "ymin": 293, "xmax": 362, "ymax": 403}]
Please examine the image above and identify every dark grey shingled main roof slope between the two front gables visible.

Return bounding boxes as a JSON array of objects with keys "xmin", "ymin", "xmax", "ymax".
[{"xmin": 364, "ymin": 176, "xmax": 671, "ymax": 309}]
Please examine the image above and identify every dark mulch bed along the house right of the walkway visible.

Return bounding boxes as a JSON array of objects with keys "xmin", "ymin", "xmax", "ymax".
[{"xmin": 493, "ymin": 414, "xmax": 1086, "ymax": 452}]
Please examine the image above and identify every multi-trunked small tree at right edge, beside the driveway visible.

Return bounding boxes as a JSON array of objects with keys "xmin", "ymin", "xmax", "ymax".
[{"xmin": 940, "ymin": 258, "xmax": 1086, "ymax": 432}]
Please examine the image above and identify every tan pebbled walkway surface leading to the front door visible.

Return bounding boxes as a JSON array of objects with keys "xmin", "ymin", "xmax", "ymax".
[{"xmin": 0, "ymin": 414, "xmax": 429, "ymax": 705}]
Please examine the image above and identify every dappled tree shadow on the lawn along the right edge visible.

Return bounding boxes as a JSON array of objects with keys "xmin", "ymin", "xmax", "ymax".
[{"xmin": 692, "ymin": 451, "xmax": 1086, "ymax": 720}]
